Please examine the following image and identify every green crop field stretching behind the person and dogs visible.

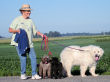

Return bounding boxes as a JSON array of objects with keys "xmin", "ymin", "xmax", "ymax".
[{"xmin": 0, "ymin": 36, "xmax": 110, "ymax": 76}]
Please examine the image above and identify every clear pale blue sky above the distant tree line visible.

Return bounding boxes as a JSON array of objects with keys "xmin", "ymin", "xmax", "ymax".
[{"xmin": 0, "ymin": 0, "xmax": 110, "ymax": 37}]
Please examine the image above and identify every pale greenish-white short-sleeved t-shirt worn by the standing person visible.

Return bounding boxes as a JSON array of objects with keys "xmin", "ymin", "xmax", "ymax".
[{"xmin": 10, "ymin": 16, "xmax": 38, "ymax": 48}]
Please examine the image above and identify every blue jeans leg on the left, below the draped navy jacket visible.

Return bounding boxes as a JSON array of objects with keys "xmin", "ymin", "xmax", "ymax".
[{"xmin": 16, "ymin": 47, "xmax": 27, "ymax": 74}]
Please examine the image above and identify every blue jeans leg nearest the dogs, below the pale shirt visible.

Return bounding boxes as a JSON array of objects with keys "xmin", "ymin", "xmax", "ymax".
[{"xmin": 29, "ymin": 48, "xmax": 37, "ymax": 75}]
